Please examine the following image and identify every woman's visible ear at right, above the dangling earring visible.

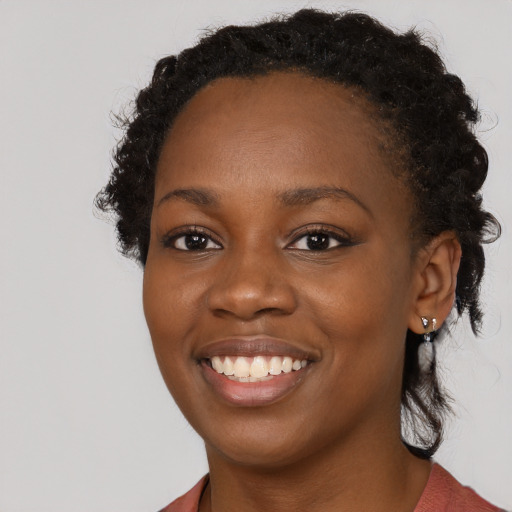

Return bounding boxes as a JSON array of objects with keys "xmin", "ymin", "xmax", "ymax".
[{"xmin": 408, "ymin": 231, "xmax": 462, "ymax": 334}]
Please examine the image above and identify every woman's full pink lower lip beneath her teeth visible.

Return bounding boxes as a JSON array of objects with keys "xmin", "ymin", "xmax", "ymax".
[{"xmin": 200, "ymin": 361, "xmax": 310, "ymax": 407}]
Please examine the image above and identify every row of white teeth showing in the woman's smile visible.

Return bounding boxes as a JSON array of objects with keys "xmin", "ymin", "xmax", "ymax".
[{"xmin": 211, "ymin": 356, "xmax": 308, "ymax": 382}]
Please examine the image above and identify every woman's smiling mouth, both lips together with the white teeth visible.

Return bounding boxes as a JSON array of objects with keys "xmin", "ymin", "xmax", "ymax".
[{"xmin": 197, "ymin": 337, "xmax": 319, "ymax": 407}]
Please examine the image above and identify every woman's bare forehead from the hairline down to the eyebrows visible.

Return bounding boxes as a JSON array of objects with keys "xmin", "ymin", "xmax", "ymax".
[{"xmin": 155, "ymin": 72, "xmax": 410, "ymax": 216}]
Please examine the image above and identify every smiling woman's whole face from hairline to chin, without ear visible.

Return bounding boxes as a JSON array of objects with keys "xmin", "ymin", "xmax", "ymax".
[{"xmin": 144, "ymin": 73, "xmax": 417, "ymax": 466}]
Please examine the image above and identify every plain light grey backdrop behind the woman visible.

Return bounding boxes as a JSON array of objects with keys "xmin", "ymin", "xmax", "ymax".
[{"xmin": 0, "ymin": 0, "xmax": 512, "ymax": 512}]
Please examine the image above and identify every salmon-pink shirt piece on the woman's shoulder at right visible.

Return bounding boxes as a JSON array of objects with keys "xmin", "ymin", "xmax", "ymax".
[{"xmin": 414, "ymin": 464, "xmax": 501, "ymax": 512}]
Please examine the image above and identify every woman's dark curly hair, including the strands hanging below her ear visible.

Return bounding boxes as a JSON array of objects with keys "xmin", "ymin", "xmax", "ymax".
[{"xmin": 96, "ymin": 9, "xmax": 500, "ymax": 458}]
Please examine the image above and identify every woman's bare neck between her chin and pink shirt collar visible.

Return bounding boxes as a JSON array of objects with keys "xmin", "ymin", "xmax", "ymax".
[{"xmin": 201, "ymin": 422, "xmax": 431, "ymax": 512}]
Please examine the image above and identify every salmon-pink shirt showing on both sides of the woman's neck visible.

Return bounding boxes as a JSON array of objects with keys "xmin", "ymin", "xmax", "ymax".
[{"xmin": 160, "ymin": 464, "xmax": 504, "ymax": 512}]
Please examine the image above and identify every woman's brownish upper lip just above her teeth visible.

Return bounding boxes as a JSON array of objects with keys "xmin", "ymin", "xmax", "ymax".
[{"xmin": 196, "ymin": 335, "xmax": 320, "ymax": 361}]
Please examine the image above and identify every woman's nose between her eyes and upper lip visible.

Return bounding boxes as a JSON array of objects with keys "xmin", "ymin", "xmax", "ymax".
[{"xmin": 208, "ymin": 249, "xmax": 297, "ymax": 321}]
